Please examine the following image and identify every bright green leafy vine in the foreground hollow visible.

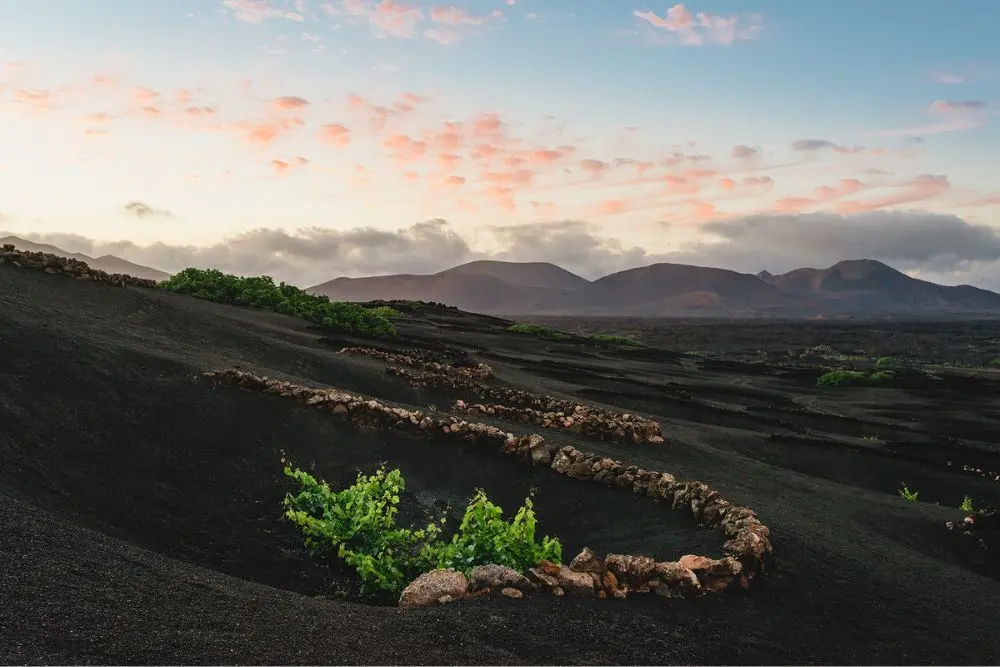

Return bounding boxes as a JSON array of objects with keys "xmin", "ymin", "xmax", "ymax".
[{"xmin": 284, "ymin": 466, "xmax": 562, "ymax": 595}]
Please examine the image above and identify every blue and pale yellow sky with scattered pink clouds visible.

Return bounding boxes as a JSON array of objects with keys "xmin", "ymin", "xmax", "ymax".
[{"xmin": 0, "ymin": 0, "xmax": 1000, "ymax": 289}]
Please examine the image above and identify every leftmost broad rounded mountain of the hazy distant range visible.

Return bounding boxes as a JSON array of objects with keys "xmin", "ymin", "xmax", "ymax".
[{"xmin": 307, "ymin": 261, "xmax": 590, "ymax": 313}]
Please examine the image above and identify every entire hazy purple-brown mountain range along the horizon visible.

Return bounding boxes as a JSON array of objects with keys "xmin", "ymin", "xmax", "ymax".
[{"xmin": 308, "ymin": 259, "xmax": 1000, "ymax": 317}]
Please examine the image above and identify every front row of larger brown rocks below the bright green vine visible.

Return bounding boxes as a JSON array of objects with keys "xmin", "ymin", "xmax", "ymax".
[{"xmin": 399, "ymin": 548, "xmax": 747, "ymax": 607}]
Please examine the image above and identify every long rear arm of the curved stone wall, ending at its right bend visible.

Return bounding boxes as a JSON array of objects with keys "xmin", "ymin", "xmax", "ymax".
[{"xmin": 204, "ymin": 369, "xmax": 773, "ymax": 581}]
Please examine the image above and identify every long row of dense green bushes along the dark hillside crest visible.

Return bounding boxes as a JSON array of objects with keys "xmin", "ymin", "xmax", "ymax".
[{"xmin": 160, "ymin": 268, "xmax": 396, "ymax": 336}]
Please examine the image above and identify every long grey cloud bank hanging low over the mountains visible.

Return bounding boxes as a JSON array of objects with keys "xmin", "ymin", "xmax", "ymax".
[{"xmin": 20, "ymin": 211, "xmax": 1000, "ymax": 287}]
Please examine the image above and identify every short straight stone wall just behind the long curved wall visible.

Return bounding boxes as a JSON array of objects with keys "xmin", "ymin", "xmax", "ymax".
[{"xmin": 453, "ymin": 401, "xmax": 663, "ymax": 445}]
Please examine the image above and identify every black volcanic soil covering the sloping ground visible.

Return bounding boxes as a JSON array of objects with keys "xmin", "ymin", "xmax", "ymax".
[{"xmin": 0, "ymin": 266, "xmax": 1000, "ymax": 664}]
